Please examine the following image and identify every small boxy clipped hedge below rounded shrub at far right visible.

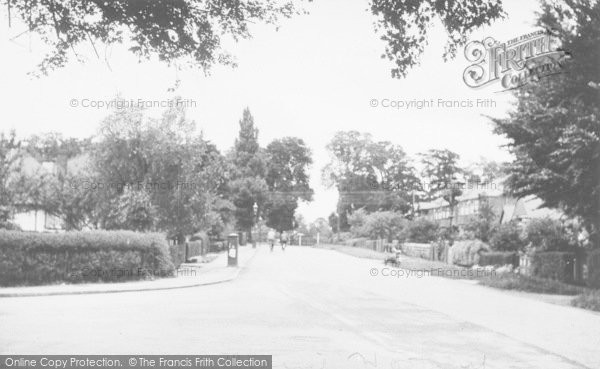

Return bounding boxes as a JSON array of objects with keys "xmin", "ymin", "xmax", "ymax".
[{"xmin": 531, "ymin": 251, "xmax": 575, "ymax": 282}]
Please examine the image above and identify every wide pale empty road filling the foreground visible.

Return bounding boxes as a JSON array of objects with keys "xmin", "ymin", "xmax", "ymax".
[{"xmin": 0, "ymin": 247, "xmax": 600, "ymax": 369}]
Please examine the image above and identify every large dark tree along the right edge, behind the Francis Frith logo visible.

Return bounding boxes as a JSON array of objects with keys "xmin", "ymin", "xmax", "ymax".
[{"xmin": 492, "ymin": 1, "xmax": 600, "ymax": 247}]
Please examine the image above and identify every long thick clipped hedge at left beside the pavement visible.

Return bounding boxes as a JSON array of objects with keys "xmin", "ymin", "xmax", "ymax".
[{"xmin": 0, "ymin": 231, "xmax": 174, "ymax": 286}]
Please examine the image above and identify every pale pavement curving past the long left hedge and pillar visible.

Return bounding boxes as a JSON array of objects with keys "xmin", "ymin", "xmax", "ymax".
[{"xmin": 0, "ymin": 247, "xmax": 256, "ymax": 298}]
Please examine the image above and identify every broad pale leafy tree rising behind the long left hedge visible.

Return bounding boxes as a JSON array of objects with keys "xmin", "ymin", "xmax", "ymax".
[{"xmin": 91, "ymin": 100, "xmax": 228, "ymax": 239}]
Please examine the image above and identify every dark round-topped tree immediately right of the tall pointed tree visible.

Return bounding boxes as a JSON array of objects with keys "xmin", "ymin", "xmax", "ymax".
[{"xmin": 265, "ymin": 137, "xmax": 313, "ymax": 232}]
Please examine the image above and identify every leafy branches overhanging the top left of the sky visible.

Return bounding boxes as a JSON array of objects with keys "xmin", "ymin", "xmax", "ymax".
[{"xmin": 4, "ymin": 0, "xmax": 308, "ymax": 74}]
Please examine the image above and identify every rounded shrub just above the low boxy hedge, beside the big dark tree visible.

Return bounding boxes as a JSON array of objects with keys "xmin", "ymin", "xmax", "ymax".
[{"xmin": 525, "ymin": 218, "xmax": 574, "ymax": 251}]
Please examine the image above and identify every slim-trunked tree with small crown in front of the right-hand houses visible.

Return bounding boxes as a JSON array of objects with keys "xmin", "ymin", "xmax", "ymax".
[{"xmin": 421, "ymin": 149, "xmax": 463, "ymax": 229}]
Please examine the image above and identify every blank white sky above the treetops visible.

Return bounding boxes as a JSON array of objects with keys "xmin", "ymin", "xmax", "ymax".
[{"xmin": 0, "ymin": 0, "xmax": 538, "ymax": 221}]
